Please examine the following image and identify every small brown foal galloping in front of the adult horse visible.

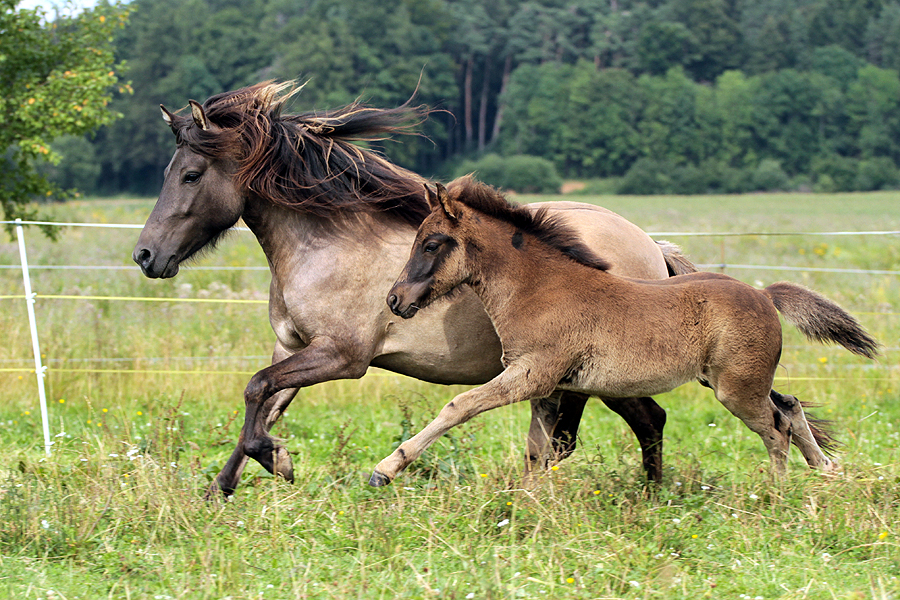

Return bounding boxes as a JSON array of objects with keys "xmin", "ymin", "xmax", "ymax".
[{"xmin": 369, "ymin": 178, "xmax": 877, "ymax": 486}]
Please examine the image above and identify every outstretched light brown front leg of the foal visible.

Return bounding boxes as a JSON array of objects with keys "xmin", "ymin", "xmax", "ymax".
[{"xmin": 369, "ymin": 364, "xmax": 558, "ymax": 487}]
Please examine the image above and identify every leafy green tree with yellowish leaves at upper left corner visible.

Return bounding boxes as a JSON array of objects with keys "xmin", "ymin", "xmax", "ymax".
[{"xmin": 0, "ymin": 0, "xmax": 129, "ymax": 229}]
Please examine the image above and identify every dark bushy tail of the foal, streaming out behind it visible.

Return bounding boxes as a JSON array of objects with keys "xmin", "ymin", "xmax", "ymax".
[{"xmin": 763, "ymin": 281, "xmax": 878, "ymax": 358}]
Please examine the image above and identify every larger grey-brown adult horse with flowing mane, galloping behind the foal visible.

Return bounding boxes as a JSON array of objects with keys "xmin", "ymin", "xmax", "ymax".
[{"xmin": 133, "ymin": 82, "xmax": 693, "ymax": 496}]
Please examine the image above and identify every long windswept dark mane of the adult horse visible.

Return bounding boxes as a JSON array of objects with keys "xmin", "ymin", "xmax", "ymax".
[{"xmin": 172, "ymin": 81, "xmax": 429, "ymax": 225}]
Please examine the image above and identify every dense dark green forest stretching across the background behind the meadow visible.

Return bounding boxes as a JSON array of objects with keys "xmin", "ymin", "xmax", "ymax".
[{"xmin": 40, "ymin": 0, "xmax": 900, "ymax": 195}]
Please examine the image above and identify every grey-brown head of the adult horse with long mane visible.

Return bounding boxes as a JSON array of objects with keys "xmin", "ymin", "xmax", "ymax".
[{"xmin": 132, "ymin": 100, "xmax": 244, "ymax": 278}]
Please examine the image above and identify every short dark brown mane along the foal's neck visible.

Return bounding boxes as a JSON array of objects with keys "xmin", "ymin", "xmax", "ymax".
[{"xmin": 447, "ymin": 175, "xmax": 610, "ymax": 271}]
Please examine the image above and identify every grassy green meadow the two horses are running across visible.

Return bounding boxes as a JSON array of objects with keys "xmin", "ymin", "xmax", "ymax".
[{"xmin": 0, "ymin": 192, "xmax": 900, "ymax": 600}]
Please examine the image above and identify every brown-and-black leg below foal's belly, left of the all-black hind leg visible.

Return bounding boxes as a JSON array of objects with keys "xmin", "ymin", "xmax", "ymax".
[{"xmin": 525, "ymin": 391, "xmax": 589, "ymax": 474}]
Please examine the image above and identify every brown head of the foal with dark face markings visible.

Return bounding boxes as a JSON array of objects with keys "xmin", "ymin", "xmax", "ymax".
[{"xmin": 387, "ymin": 184, "xmax": 468, "ymax": 319}]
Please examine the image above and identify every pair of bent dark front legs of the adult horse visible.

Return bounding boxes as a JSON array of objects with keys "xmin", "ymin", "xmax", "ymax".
[{"xmin": 207, "ymin": 336, "xmax": 369, "ymax": 497}]
